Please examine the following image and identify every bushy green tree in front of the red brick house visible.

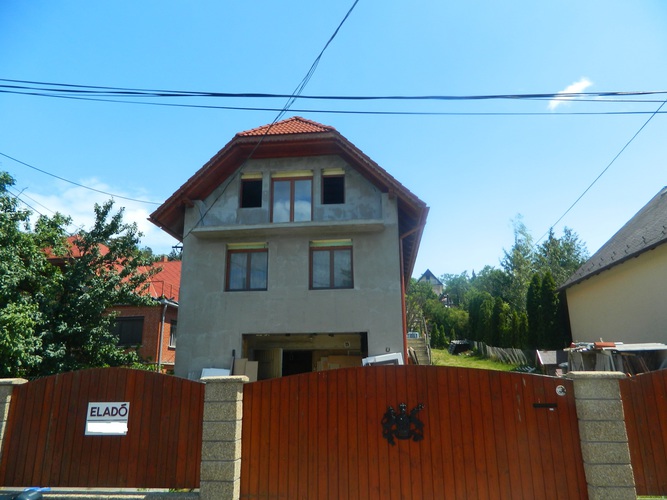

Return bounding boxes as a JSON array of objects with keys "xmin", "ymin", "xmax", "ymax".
[{"xmin": 39, "ymin": 201, "xmax": 155, "ymax": 374}]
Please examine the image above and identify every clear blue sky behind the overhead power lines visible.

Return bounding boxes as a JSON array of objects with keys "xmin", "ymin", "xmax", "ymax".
[{"xmin": 0, "ymin": 0, "xmax": 667, "ymax": 276}]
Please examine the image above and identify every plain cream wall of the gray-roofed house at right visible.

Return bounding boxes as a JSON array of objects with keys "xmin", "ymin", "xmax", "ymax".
[{"xmin": 566, "ymin": 245, "xmax": 667, "ymax": 343}]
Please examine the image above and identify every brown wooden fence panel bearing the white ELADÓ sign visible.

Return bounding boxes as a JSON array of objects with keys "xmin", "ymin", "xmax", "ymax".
[{"xmin": 0, "ymin": 368, "xmax": 204, "ymax": 488}]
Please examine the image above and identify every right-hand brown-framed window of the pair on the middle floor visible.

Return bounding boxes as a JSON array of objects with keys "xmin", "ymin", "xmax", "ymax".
[{"xmin": 310, "ymin": 240, "xmax": 354, "ymax": 290}]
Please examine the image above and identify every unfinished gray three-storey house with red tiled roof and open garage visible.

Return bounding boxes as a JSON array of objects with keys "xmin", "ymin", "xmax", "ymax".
[{"xmin": 150, "ymin": 117, "xmax": 428, "ymax": 379}]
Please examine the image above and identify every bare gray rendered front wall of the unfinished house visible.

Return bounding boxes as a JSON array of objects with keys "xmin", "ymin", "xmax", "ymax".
[{"xmin": 175, "ymin": 156, "xmax": 403, "ymax": 378}]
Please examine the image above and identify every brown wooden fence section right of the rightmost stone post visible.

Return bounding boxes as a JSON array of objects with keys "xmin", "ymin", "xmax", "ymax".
[{"xmin": 620, "ymin": 370, "xmax": 667, "ymax": 495}]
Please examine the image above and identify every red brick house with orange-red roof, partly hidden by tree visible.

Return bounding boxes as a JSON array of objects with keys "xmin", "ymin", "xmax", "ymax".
[{"xmin": 47, "ymin": 236, "xmax": 181, "ymax": 371}]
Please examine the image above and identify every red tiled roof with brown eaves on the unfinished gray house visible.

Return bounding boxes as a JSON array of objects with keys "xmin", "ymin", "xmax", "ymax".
[{"xmin": 149, "ymin": 116, "xmax": 428, "ymax": 280}]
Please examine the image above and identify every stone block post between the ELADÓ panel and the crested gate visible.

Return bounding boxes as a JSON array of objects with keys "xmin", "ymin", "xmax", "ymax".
[{"xmin": 199, "ymin": 376, "xmax": 248, "ymax": 500}]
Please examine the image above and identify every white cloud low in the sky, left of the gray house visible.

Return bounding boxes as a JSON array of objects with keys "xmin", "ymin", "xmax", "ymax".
[{"xmin": 24, "ymin": 179, "xmax": 178, "ymax": 254}]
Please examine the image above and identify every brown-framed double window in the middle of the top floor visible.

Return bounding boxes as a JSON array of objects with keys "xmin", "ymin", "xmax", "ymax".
[{"xmin": 271, "ymin": 177, "xmax": 313, "ymax": 222}]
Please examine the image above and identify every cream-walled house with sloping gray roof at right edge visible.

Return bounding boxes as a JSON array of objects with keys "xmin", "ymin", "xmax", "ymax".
[{"xmin": 561, "ymin": 188, "xmax": 667, "ymax": 343}]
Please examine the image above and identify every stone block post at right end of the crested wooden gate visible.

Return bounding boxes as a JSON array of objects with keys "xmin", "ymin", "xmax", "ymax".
[{"xmin": 566, "ymin": 371, "xmax": 637, "ymax": 500}]
